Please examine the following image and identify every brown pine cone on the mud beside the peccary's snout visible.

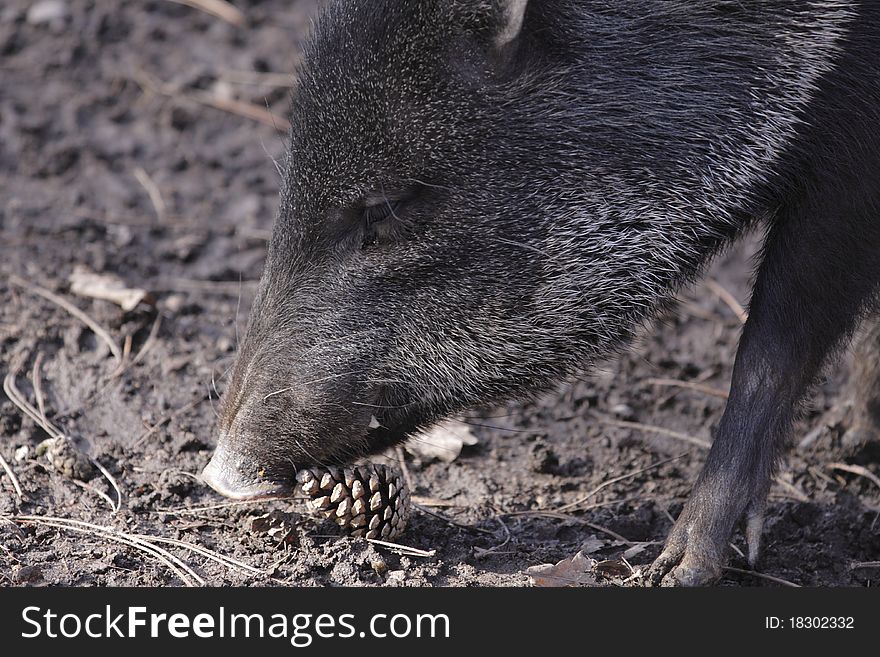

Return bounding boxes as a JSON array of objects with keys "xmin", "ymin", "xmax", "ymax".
[{"xmin": 297, "ymin": 465, "xmax": 410, "ymax": 540}]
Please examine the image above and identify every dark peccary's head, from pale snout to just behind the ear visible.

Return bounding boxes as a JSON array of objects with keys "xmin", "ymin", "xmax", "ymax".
[{"xmin": 204, "ymin": 0, "xmax": 575, "ymax": 497}]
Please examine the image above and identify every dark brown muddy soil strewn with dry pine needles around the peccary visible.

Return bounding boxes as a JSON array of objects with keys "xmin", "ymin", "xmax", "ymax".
[{"xmin": 0, "ymin": 0, "xmax": 880, "ymax": 586}]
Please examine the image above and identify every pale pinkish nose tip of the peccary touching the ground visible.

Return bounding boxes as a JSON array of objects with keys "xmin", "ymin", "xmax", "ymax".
[{"xmin": 202, "ymin": 445, "xmax": 292, "ymax": 500}]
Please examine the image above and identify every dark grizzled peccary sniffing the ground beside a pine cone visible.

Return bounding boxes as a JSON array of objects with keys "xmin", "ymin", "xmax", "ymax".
[{"xmin": 204, "ymin": 0, "xmax": 880, "ymax": 584}]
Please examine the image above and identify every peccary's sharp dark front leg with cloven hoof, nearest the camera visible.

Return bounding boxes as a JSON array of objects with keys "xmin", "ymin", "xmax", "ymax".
[{"xmin": 649, "ymin": 197, "xmax": 880, "ymax": 586}]
